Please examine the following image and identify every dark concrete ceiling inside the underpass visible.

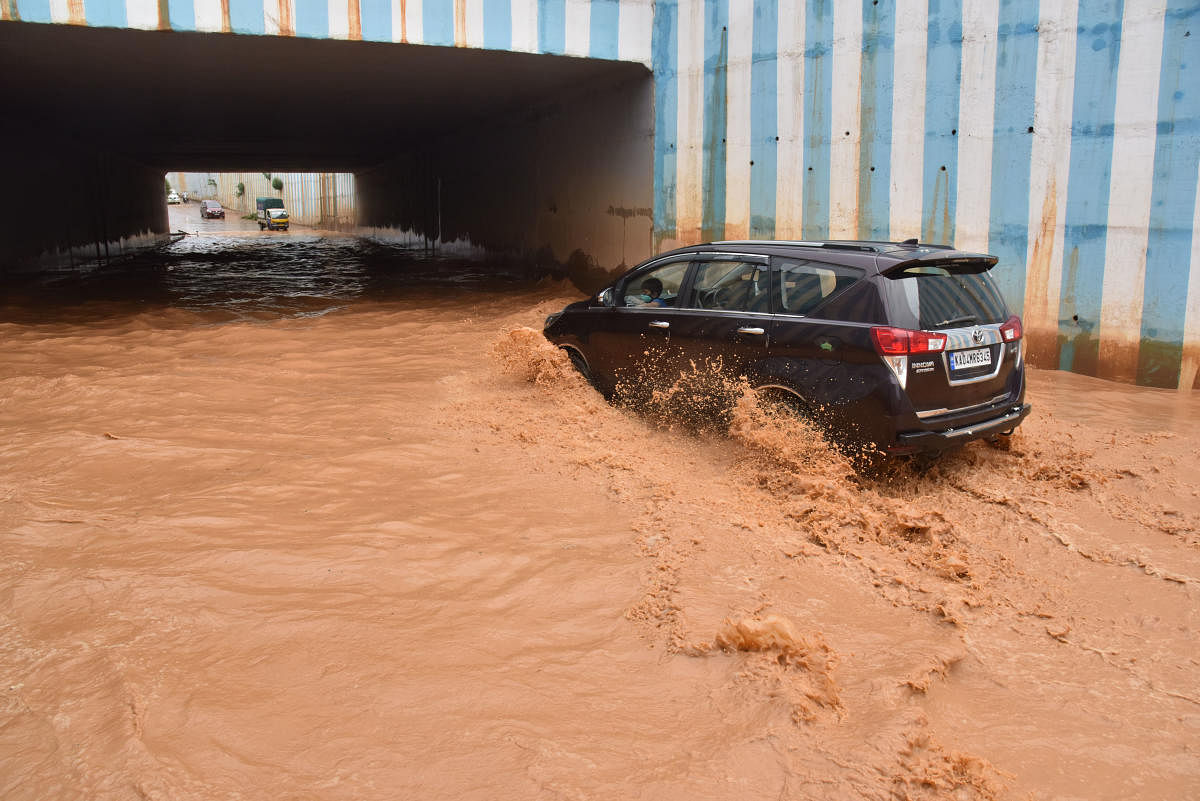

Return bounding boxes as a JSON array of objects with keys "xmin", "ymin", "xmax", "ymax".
[{"xmin": 0, "ymin": 22, "xmax": 649, "ymax": 171}]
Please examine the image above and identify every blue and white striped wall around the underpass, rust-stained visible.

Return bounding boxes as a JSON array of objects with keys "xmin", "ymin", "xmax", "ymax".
[{"xmin": 0, "ymin": 0, "xmax": 1200, "ymax": 387}]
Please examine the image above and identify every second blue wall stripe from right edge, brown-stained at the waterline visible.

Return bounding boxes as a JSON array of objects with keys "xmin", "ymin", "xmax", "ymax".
[{"xmin": 1058, "ymin": 0, "xmax": 1124, "ymax": 374}]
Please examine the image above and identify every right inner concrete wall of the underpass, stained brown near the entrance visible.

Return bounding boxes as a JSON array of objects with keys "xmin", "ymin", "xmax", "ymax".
[{"xmin": 356, "ymin": 71, "xmax": 653, "ymax": 288}]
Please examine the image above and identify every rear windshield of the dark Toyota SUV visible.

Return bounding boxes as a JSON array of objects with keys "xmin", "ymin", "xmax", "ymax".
[{"xmin": 888, "ymin": 261, "xmax": 1008, "ymax": 330}]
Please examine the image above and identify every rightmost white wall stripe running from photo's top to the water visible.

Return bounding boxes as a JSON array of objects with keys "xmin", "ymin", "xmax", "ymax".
[{"xmin": 1100, "ymin": 0, "xmax": 1166, "ymax": 366}]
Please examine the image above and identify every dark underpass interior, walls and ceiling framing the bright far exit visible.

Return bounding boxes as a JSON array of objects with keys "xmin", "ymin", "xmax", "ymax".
[{"xmin": 0, "ymin": 22, "xmax": 654, "ymax": 291}]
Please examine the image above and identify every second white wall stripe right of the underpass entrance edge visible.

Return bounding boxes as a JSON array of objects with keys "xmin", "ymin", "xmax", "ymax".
[{"xmin": 718, "ymin": 0, "xmax": 754, "ymax": 239}]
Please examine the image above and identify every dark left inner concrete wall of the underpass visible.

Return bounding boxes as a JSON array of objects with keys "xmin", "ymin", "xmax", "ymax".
[{"xmin": 0, "ymin": 138, "xmax": 167, "ymax": 273}]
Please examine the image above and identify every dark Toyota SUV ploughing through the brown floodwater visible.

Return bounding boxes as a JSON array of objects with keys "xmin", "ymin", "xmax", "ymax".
[{"xmin": 545, "ymin": 240, "xmax": 1030, "ymax": 454}]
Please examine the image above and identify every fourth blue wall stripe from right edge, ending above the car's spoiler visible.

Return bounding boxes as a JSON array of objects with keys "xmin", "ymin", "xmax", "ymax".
[{"xmin": 920, "ymin": 0, "xmax": 962, "ymax": 245}]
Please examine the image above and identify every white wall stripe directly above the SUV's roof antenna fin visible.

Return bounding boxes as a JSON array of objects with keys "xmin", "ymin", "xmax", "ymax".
[{"xmin": 888, "ymin": 0, "xmax": 929, "ymax": 240}]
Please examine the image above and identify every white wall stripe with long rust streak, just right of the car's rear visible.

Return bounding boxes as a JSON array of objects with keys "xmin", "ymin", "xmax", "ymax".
[{"xmin": 1025, "ymin": 2, "xmax": 1078, "ymax": 344}]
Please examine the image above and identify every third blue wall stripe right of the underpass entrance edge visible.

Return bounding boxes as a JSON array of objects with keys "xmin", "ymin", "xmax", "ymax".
[{"xmin": 750, "ymin": 0, "xmax": 779, "ymax": 239}]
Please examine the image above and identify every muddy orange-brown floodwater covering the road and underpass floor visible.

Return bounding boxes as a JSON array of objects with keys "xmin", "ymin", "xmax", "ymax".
[{"xmin": 0, "ymin": 231, "xmax": 1200, "ymax": 801}]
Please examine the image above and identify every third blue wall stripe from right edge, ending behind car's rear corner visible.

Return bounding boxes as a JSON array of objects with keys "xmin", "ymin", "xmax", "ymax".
[{"xmin": 988, "ymin": 0, "xmax": 1039, "ymax": 314}]
